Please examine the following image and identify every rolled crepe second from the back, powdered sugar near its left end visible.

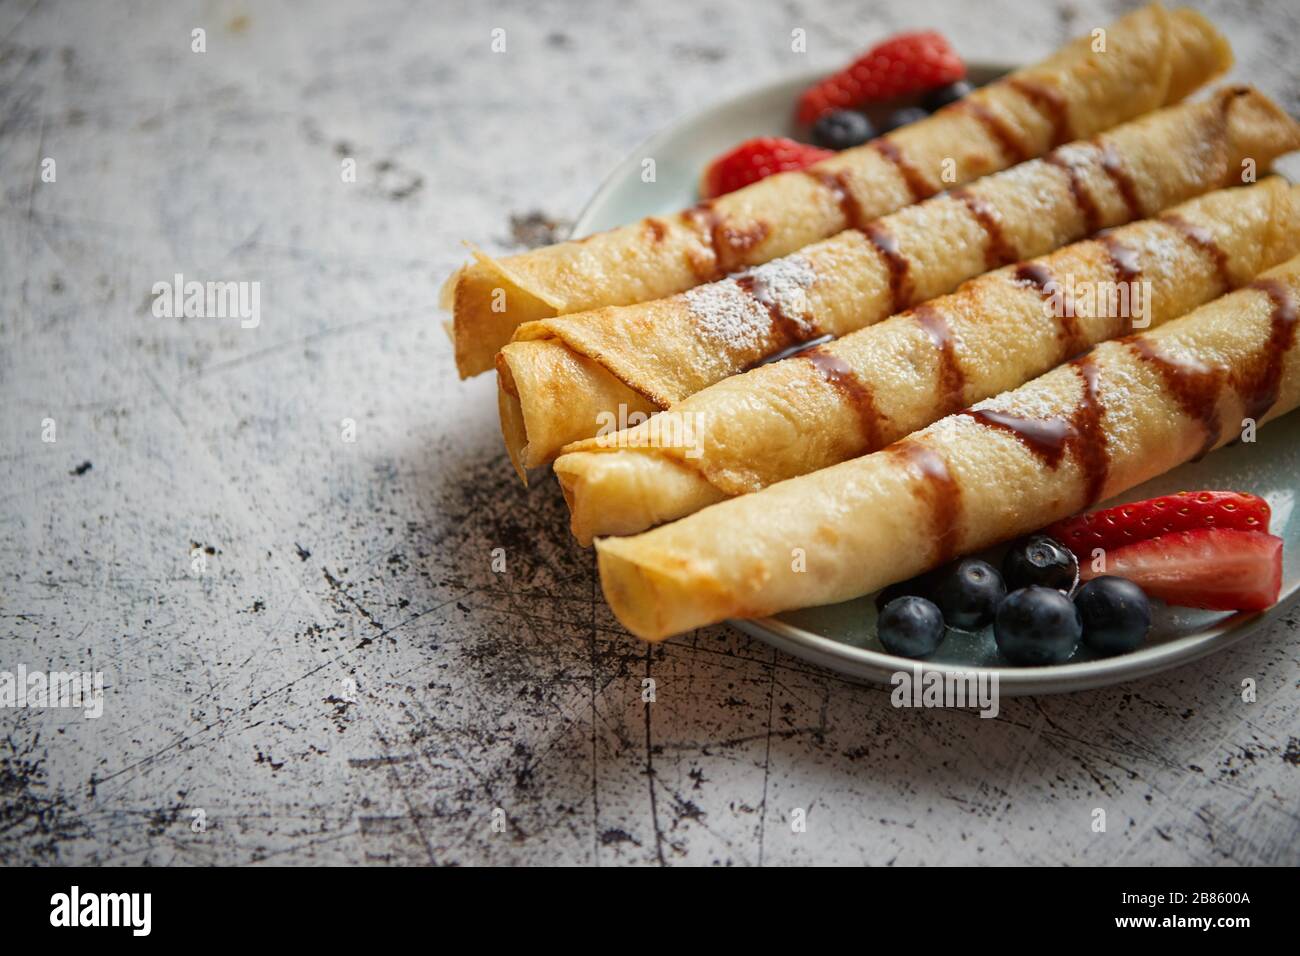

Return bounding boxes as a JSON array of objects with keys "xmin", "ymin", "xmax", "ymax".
[{"xmin": 497, "ymin": 87, "xmax": 1300, "ymax": 476}]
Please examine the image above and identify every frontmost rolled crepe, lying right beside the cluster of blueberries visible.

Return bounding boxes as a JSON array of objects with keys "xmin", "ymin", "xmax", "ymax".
[{"xmin": 595, "ymin": 258, "xmax": 1300, "ymax": 640}]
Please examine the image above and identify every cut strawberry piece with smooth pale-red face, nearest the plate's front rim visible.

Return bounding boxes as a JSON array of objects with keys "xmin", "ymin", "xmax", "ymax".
[{"xmin": 1079, "ymin": 528, "xmax": 1282, "ymax": 611}]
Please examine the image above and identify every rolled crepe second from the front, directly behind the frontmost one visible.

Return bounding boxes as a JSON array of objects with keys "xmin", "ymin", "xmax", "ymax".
[{"xmin": 555, "ymin": 177, "xmax": 1300, "ymax": 545}]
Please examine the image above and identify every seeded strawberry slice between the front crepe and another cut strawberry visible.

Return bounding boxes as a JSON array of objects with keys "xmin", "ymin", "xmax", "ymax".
[{"xmin": 1047, "ymin": 492, "xmax": 1270, "ymax": 562}]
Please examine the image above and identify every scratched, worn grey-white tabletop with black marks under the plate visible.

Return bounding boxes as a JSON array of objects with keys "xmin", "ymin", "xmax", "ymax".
[{"xmin": 0, "ymin": 0, "xmax": 1300, "ymax": 865}]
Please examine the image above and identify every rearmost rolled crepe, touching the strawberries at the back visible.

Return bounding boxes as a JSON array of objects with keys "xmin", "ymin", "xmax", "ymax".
[{"xmin": 452, "ymin": 4, "xmax": 1232, "ymax": 377}]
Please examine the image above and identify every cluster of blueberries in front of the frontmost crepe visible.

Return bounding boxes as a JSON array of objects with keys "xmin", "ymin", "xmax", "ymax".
[{"xmin": 878, "ymin": 535, "xmax": 1151, "ymax": 666}]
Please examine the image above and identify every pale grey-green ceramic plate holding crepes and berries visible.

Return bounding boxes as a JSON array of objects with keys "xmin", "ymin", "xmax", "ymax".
[{"xmin": 575, "ymin": 65, "xmax": 1300, "ymax": 695}]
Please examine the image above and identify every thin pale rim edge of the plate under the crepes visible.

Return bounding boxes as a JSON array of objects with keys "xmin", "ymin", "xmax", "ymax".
[{"xmin": 571, "ymin": 60, "xmax": 1300, "ymax": 696}]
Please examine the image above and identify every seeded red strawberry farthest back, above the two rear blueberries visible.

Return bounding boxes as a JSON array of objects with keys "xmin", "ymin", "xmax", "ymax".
[{"xmin": 797, "ymin": 30, "xmax": 966, "ymax": 124}]
